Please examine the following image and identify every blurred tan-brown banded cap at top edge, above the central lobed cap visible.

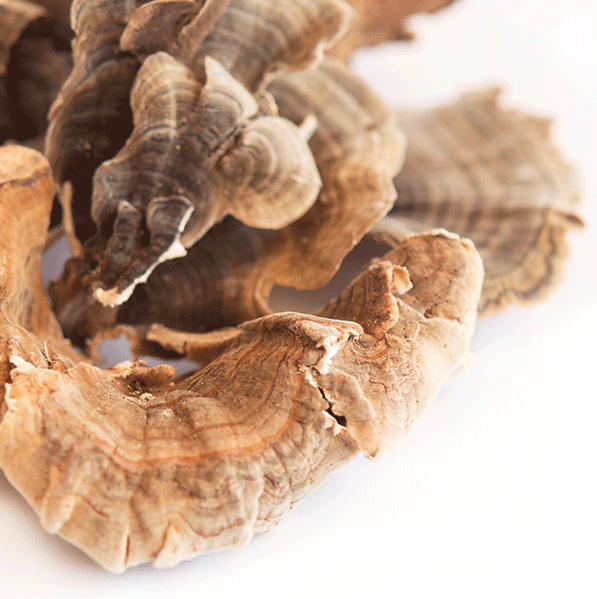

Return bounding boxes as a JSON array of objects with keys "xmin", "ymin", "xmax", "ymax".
[{"xmin": 120, "ymin": 0, "xmax": 353, "ymax": 92}]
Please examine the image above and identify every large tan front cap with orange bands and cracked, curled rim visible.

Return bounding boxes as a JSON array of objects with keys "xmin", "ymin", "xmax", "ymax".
[{"xmin": 0, "ymin": 151, "xmax": 482, "ymax": 571}]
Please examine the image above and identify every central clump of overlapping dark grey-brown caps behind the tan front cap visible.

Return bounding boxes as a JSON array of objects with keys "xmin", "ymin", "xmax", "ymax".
[{"xmin": 46, "ymin": 0, "xmax": 404, "ymax": 346}]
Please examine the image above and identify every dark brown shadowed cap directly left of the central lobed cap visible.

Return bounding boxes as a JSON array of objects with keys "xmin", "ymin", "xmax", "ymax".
[{"xmin": 45, "ymin": 0, "xmax": 139, "ymax": 241}]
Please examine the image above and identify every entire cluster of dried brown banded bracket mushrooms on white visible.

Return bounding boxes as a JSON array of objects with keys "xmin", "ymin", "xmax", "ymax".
[{"xmin": 0, "ymin": 0, "xmax": 581, "ymax": 571}]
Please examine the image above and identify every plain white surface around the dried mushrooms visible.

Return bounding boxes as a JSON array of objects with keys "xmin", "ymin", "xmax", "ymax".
[{"xmin": 0, "ymin": 0, "xmax": 597, "ymax": 599}]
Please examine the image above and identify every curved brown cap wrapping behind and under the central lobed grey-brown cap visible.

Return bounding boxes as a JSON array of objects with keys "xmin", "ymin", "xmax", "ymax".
[{"xmin": 51, "ymin": 58, "xmax": 405, "ymax": 345}]
